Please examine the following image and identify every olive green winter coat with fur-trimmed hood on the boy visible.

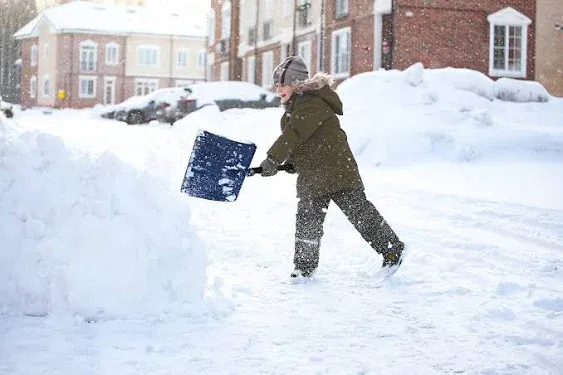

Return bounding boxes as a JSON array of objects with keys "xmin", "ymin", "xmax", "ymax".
[{"xmin": 268, "ymin": 73, "xmax": 363, "ymax": 198}]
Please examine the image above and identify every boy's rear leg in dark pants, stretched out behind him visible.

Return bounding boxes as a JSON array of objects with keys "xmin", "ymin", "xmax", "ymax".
[{"xmin": 332, "ymin": 189, "xmax": 404, "ymax": 257}]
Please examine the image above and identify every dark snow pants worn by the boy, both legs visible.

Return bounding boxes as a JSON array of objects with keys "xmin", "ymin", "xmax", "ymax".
[{"xmin": 293, "ymin": 190, "xmax": 399, "ymax": 271}]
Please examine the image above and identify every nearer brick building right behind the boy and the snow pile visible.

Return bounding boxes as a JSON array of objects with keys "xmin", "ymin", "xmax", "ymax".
[{"xmin": 208, "ymin": 0, "xmax": 563, "ymax": 95}]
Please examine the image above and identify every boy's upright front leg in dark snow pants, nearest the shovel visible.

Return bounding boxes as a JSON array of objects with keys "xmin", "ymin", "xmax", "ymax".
[{"xmin": 293, "ymin": 196, "xmax": 330, "ymax": 276}]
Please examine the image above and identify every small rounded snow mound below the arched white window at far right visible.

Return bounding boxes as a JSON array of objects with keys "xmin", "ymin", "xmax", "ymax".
[{"xmin": 494, "ymin": 78, "xmax": 551, "ymax": 103}]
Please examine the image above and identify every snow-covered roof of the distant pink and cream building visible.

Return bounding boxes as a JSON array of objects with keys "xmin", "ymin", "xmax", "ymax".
[{"xmin": 14, "ymin": 1, "xmax": 206, "ymax": 39}]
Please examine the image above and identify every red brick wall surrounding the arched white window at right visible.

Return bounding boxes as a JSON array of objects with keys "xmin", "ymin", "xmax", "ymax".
[{"xmin": 393, "ymin": 0, "xmax": 536, "ymax": 79}]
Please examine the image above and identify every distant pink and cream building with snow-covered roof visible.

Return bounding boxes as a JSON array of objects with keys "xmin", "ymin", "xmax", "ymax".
[{"xmin": 14, "ymin": 1, "xmax": 206, "ymax": 108}]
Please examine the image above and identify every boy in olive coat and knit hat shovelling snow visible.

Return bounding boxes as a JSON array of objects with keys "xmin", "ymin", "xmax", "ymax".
[{"xmin": 260, "ymin": 56, "xmax": 404, "ymax": 277}]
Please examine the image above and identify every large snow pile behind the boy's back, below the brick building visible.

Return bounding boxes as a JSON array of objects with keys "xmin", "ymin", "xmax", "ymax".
[{"xmin": 337, "ymin": 64, "xmax": 563, "ymax": 165}]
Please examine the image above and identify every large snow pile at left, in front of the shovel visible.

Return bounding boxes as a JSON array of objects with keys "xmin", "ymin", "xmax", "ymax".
[{"xmin": 0, "ymin": 119, "xmax": 207, "ymax": 319}]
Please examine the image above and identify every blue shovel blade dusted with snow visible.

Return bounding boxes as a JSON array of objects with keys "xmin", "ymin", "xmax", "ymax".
[{"xmin": 180, "ymin": 130, "xmax": 256, "ymax": 202}]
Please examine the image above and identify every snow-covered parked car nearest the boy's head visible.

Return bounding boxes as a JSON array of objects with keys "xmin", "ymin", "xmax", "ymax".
[{"xmin": 175, "ymin": 81, "xmax": 280, "ymax": 120}]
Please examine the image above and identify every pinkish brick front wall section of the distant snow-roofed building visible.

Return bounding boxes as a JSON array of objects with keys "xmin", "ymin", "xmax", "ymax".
[{"xmin": 57, "ymin": 34, "xmax": 126, "ymax": 108}]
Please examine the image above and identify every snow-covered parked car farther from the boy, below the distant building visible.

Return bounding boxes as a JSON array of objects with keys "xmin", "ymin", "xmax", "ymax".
[{"xmin": 112, "ymin": 87, "xmax": 190, "ymax": 125}]
